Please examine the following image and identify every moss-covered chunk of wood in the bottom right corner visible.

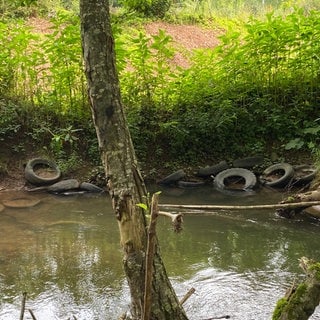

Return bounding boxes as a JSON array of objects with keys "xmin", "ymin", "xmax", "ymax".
[{"xmin": 272, "ymin": 257, "xmax": 320, "ymax": 320}]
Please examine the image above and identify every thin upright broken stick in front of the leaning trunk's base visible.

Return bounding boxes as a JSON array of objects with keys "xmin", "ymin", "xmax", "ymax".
[{"xmin": 142, "ymin": 193, "xmax": 159, "ymax": 320}]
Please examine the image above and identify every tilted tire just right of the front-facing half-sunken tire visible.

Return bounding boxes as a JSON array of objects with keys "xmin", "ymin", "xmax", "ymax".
[{"xmin": 260, "ymin": 163, "xmax": 294, "ymax": 188}]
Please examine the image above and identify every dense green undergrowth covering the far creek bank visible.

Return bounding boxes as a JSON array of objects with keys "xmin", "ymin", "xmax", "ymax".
[{"xmin": 0, "ymin": 0, "xmax": 320, "ymax": 180}]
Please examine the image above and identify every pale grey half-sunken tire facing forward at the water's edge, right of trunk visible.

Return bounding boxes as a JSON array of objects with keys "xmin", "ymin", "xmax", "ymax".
[{"xmin": 213, "ymin": 168, "xmax": 257, "ymax": 191}]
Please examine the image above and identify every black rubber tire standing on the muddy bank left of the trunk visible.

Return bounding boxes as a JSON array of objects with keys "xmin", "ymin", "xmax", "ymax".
[{"xmin": 24, "ymin": 158, "xmax": 61, "ymax": 186}]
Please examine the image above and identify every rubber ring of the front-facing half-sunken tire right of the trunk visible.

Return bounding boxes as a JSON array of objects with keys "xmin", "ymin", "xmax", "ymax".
[{"xmin": 213, "ymin": 168, "xmax": 257, "ymax": 191}]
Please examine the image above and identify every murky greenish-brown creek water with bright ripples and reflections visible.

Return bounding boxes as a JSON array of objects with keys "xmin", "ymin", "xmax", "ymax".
[{"xmin": 0, "ymin": 186, "xmax": 320, "ymax": 320}]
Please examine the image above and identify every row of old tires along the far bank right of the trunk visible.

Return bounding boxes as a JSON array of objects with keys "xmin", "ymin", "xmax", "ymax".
[{"xmin": 159, "ymin": 156, "xmax": 317, "ymax": 191}]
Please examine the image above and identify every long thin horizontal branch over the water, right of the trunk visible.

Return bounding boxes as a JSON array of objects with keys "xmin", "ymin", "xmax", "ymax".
[{"xmin": 158, "ymin": 201, "xmax": 320, "ymax": 214}]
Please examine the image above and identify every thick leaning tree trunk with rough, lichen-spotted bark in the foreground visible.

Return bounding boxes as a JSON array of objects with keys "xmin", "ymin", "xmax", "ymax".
[{"xmin": 80, "ymin": 0, "xmax": 187, "ymax": 320}]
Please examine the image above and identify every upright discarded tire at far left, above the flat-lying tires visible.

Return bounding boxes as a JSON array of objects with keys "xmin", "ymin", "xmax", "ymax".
[{"xmin": 24, "ymin": 158, "xmax": 61, "ymax": 186}]
